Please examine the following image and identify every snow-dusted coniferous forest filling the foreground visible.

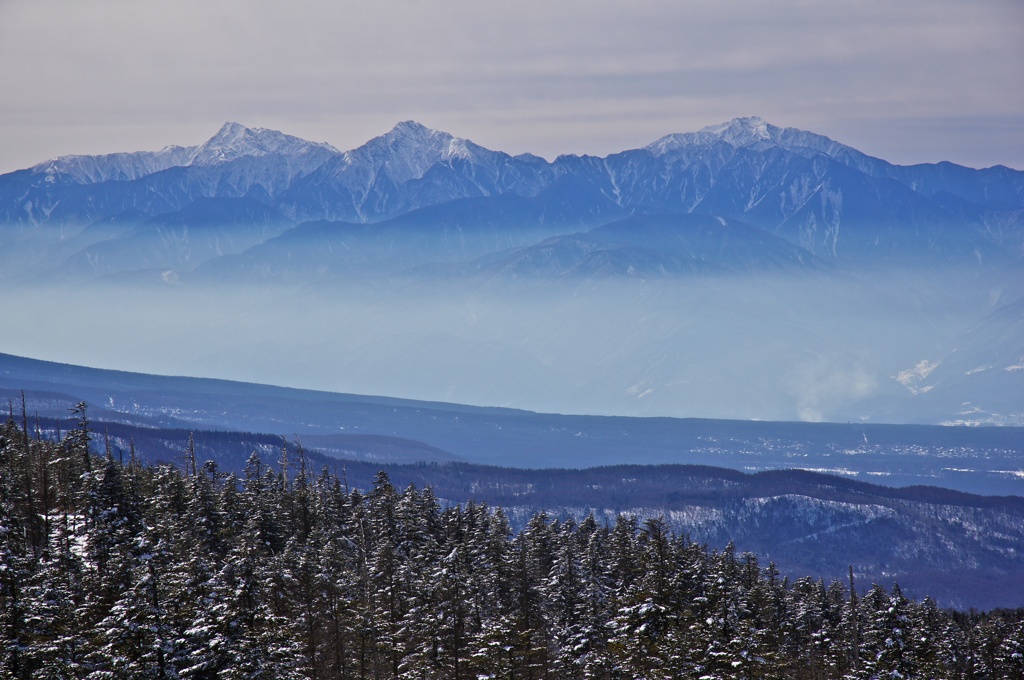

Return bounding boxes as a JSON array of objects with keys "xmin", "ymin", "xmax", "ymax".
[{"xmin": 0, "ymin": 405, "xmax": 1024, "ymax": 680}]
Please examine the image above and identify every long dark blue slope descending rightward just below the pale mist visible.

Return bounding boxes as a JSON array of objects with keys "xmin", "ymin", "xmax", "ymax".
[{"xmin": 0, "ymin": 354, "xmax": 1024, "ymax": 496}]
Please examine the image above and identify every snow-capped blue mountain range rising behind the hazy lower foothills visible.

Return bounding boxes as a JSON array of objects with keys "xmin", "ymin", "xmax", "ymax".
[{"xmin": 0, "ymin": 118, "xmax": 1024, "ymax": 280}]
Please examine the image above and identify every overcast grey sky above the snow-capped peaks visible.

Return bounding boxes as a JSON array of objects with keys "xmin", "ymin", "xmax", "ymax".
[{"xmin": 0, "ymin": 0, "xmax": 1024, "ymax": 172}]
